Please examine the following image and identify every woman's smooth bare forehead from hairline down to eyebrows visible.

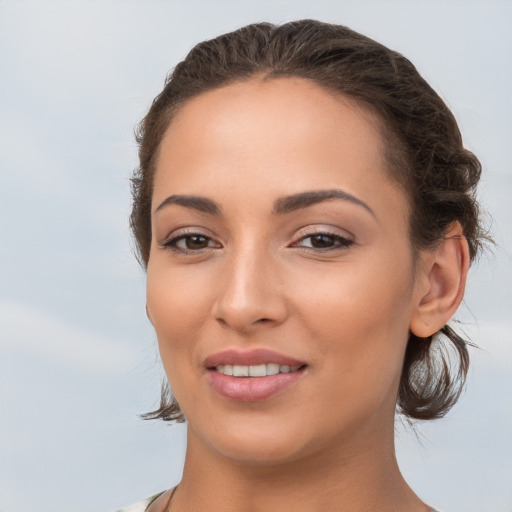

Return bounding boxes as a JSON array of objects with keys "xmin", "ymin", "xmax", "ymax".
[{"xmin": 154, "ymin": 78, "xmax": 404, "ymax": 217}]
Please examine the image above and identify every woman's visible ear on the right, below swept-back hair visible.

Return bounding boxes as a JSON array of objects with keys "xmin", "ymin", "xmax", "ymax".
[{"xmin": 410, "ymin": 222, "xmax": 470, "ymax": 338}]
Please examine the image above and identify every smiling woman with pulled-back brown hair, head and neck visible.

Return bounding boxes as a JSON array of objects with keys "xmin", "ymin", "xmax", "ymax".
[{"xmin": 119, "ymin": 20, "xmax": 484, "ymax": 512}]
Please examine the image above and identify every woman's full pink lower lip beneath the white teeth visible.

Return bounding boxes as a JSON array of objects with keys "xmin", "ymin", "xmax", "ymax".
[{"xmin": 208, "ymin": 368, "xmax": 304, "ymax": 402}]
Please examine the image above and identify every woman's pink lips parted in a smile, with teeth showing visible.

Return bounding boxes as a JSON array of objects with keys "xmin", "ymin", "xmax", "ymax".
[{"xmin": 204, "ymin": 349, "xmax": 307, "ymax": 402}]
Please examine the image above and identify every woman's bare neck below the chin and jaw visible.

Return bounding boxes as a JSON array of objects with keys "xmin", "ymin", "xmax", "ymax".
[{"xmin": 172, "ymin": 420, "xmax": 428, "ymax": 512}]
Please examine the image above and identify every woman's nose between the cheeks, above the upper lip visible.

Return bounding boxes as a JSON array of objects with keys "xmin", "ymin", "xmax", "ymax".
[{"xmin": 213, "ymin": 248, "xmax": 288, "ymax": 334}]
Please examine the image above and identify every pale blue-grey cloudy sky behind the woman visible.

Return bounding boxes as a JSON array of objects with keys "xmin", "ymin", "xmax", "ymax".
[{"xmin": 0, "ymin": 0, "xmax": 512, "ymax": 512}]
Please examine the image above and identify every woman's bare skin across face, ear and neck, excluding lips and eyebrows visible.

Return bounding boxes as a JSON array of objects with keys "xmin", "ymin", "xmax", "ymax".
[{"xmin": 147, "ymin": 78, "xmax": 468, "ymax": 512}]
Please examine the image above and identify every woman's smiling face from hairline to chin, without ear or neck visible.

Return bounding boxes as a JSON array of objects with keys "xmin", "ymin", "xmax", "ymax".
[{"xmin": 147, "ymin": 78, "xmax": 418, "ymax": 463}]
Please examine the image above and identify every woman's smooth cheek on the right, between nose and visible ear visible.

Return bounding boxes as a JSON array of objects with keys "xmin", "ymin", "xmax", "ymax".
[{"xmin": 290, "ymin": 252, "xmax": 413, "ymax": 392}]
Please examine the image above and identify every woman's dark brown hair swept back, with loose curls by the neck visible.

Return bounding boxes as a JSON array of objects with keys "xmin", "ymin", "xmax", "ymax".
[{"xmin": 130, "ymin": 20, "xmax": 487, "ymax": 421}]
